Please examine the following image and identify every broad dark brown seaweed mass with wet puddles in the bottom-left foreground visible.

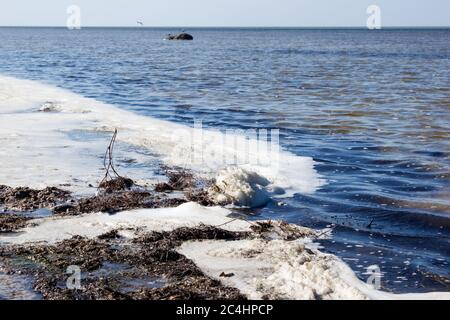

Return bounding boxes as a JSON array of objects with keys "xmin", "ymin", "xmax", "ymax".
[{"xmin": 0, "ymin": 226, "xmax": 249, "ymax": 300}]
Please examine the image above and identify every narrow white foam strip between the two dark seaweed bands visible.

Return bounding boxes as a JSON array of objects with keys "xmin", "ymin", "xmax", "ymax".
[{"xmin": 0, "ymin": 202, "xmax": 249, "ymax": 244}]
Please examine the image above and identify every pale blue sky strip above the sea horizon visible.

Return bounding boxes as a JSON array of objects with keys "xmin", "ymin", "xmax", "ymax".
[{"xmin": 0, "ymin": 0, "xmax": 450, "ymax": 27}]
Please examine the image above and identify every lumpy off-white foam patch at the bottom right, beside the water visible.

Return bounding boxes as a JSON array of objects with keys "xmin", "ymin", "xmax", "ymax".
[{"xmin": 179, "ymin": 239, "xmax": 450, "ymax": 300}]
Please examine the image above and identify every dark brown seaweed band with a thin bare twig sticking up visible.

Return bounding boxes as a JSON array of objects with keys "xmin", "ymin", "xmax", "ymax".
[{"xmin": 0, "ymin": 130, "xmax": 264, "ymax": 218}]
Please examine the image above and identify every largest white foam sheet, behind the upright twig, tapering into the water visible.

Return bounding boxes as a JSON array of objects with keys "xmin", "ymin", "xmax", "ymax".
[{"xmin": 0, "ymin": 76, "xmax": 324, "ymax": 203}]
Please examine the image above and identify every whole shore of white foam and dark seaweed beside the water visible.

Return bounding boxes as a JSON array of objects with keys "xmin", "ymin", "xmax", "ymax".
[{"xmin": 0, "ymin": 77, "xmax": 450, "ymax": 299}]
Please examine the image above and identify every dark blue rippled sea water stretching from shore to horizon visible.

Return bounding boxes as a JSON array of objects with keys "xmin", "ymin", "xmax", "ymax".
[{"xmin": 0, "ymin": 28, "xmax": 450, "ymax": 292}]
